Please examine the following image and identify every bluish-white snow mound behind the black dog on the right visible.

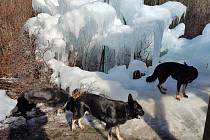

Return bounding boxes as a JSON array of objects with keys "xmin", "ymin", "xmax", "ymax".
[{"xmin": 160, "ymin": 24, "xmax": 210, "ymax": 73}]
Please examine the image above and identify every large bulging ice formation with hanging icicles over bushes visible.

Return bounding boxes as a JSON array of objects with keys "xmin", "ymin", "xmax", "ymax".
[{"xmin": 25, "ymin": 0, "xmax": 186, "ymax": 71}]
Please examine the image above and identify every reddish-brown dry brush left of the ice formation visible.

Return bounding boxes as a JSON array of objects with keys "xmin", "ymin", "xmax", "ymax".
[{"xmin": 0, "ymin": 0, "xmax": 52, "ymax": 92}]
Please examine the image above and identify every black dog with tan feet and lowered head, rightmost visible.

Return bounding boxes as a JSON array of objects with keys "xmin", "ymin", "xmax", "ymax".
[{"xmin": 146, "ymin": 62, "xmax": 198, "ymax": 100}]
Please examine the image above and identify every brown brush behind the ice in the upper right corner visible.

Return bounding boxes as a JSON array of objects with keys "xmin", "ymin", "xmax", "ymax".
[{"xmin": 144, "ymin": 0, "xmax": 210, "ymax": 38}]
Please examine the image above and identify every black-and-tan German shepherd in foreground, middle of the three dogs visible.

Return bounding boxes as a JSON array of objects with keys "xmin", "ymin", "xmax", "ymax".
[{"xmin": 66, "ymin": 93, "xmax": 144, "ymax": 140}]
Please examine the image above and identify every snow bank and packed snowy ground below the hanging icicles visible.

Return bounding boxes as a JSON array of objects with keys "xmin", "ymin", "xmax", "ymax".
[{"xmin": 46, "ymin": 60, "xmax": 210, "ymax": 140}]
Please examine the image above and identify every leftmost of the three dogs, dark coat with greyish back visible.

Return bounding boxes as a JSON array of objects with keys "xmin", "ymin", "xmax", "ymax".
[{"xmin": 11, "ymin": 88, "xmax": 68, "ymax": 118}]
